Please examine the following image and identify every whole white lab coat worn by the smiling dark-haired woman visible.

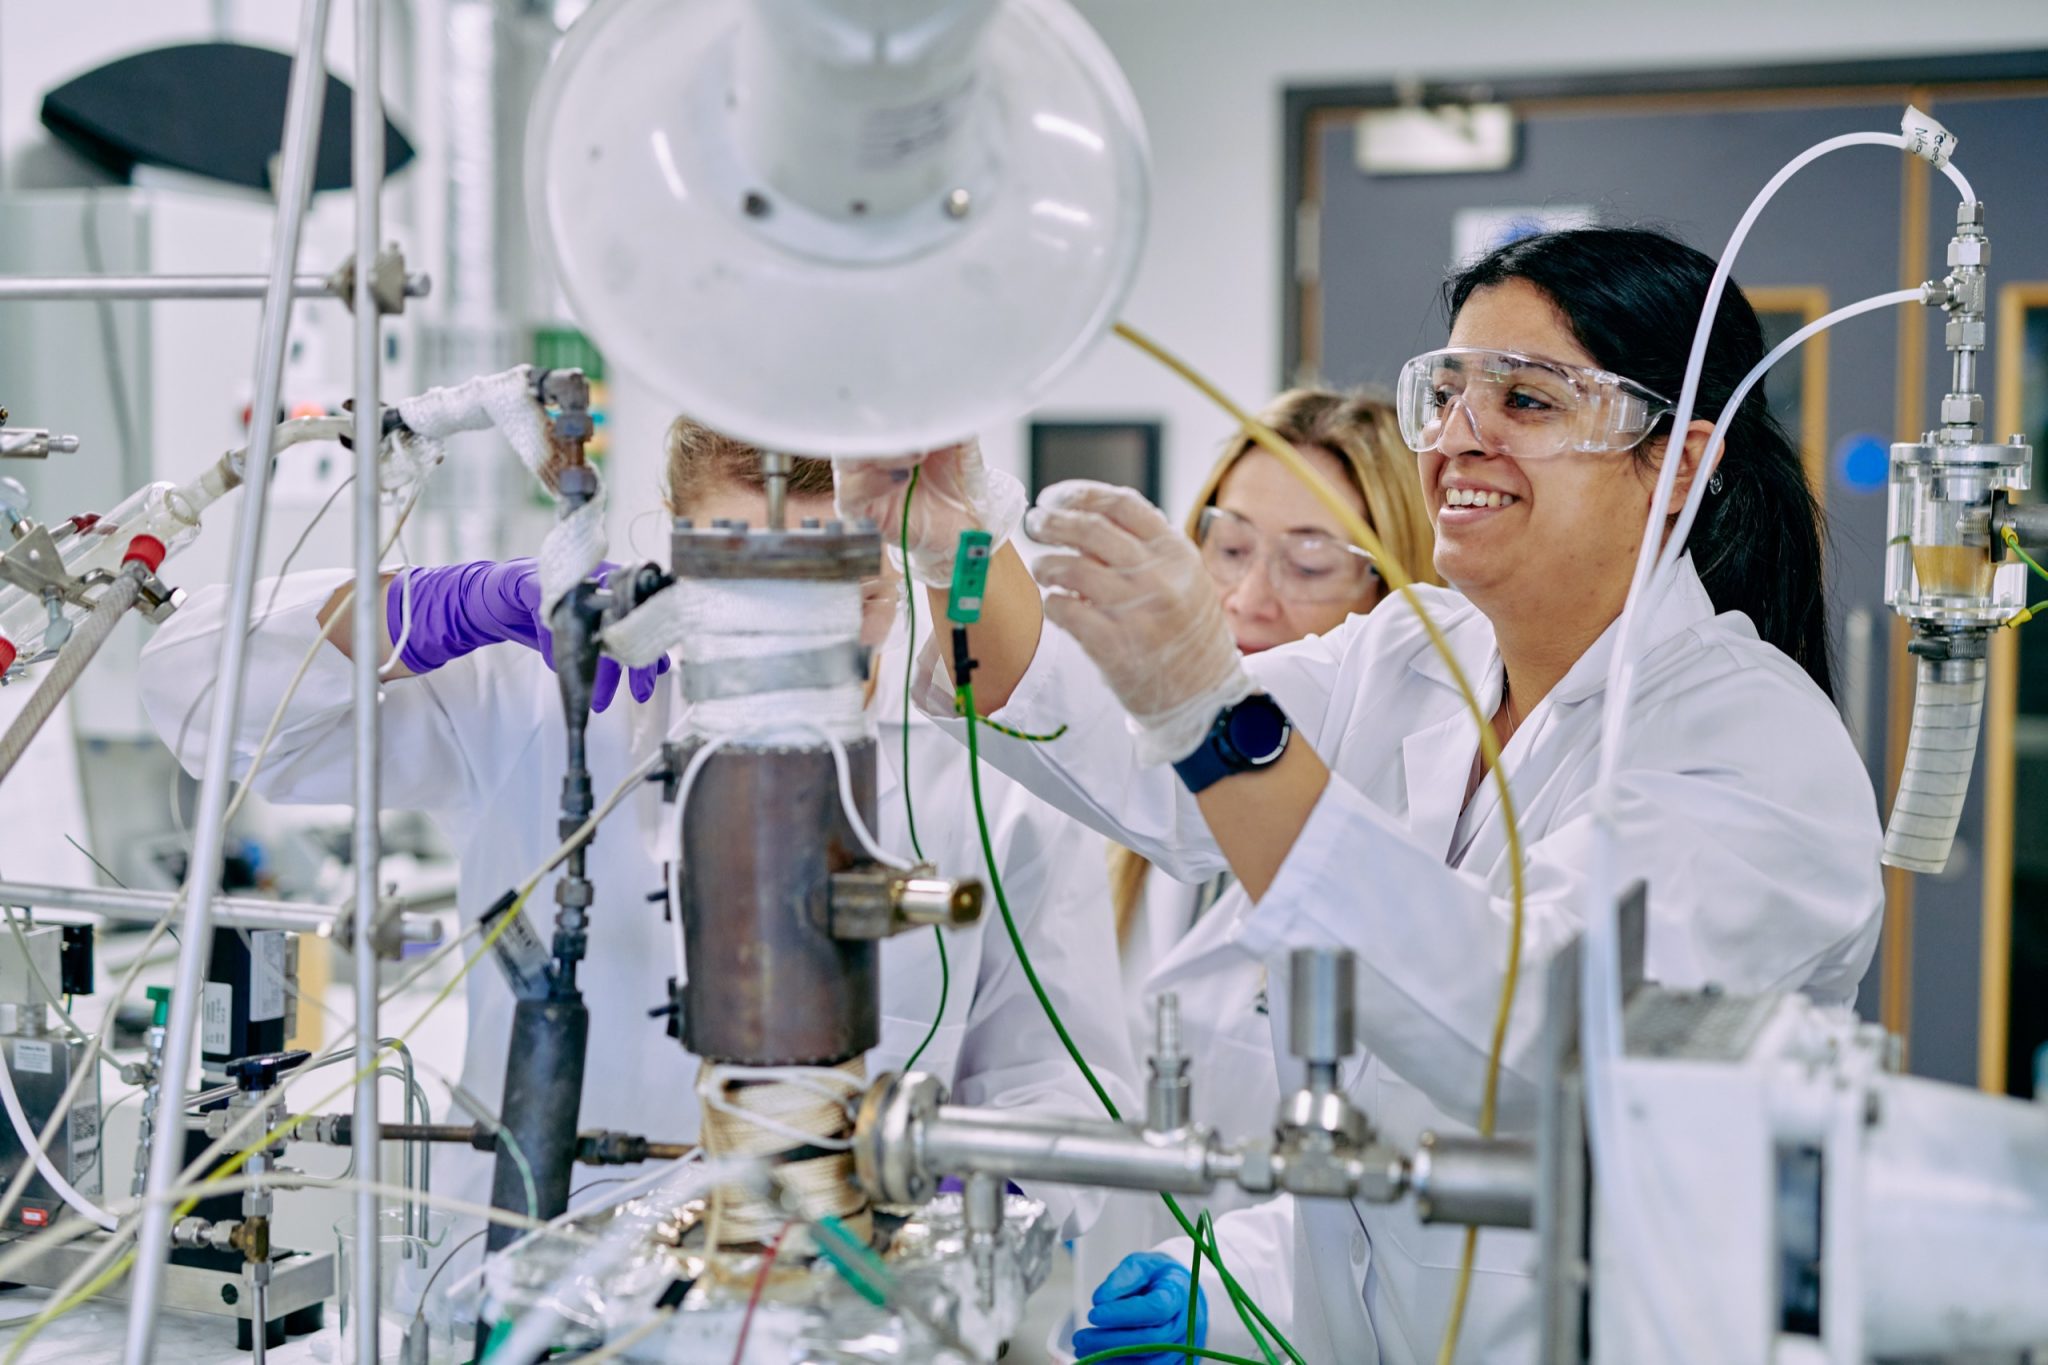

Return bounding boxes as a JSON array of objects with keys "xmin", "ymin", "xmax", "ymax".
[{"xmin": 920, "ymin": 559, "xmax": 1882, "ymax": 1365}]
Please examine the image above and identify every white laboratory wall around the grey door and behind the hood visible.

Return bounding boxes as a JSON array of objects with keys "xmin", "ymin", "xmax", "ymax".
[{"xmin": 12, "ymin": 0, "xmax": 2048, "ymax": 540}]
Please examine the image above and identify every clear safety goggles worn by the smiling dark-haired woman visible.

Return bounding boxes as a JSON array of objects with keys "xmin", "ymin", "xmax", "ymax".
[{"xmin": 1395, "ymin": 346, "xmax": 1671, "ymax": 456}]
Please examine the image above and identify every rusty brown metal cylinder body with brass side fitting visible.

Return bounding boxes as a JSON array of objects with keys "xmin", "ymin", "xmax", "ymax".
[{"xmin": 680, "ymin": 741, "xmax": 881, "ymax": 1066}]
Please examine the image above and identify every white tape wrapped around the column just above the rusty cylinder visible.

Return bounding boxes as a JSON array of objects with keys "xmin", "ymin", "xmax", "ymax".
[{"xmin": 675, "ymin": 579, "xmax": 868, "ymax": 745}]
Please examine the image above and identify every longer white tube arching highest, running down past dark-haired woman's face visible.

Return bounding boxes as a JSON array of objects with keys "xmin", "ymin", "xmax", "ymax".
[{"xmin": 1579, "ymin": 133, "xmax": 1974, "ymax": 1361}]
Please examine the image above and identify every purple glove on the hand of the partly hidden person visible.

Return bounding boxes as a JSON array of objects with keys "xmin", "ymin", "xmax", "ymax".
[{"xmin": 385, "ymin": 559, "xmax": 668, "ymax": 710}]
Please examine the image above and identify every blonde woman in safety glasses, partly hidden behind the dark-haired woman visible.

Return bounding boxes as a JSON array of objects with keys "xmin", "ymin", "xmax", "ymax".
[{"xmin": 1075, "ymin": 389, "xmax": 1438, "ymax": 1308}]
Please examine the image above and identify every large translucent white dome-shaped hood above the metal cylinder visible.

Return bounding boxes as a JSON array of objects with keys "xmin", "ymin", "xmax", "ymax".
[{"xmin": 526, "ymin": 0, "xmax": 1147, "ymax": 456}]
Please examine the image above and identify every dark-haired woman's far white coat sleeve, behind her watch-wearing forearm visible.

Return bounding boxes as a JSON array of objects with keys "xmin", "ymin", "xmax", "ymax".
[{"xmin": 915, "ymin": 618, "xmax": 1364, "ymax": 882}]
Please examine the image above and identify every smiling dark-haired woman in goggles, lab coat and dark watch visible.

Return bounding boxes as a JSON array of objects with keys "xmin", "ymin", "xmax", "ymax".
[{"xmin": 840, "ymin": 229, "xmax": 1880, "ymax": 1361}]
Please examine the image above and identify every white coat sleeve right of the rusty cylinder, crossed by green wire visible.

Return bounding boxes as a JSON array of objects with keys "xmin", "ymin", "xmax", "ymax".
[{"xmin": 954, "ymin": 753, "xmax": 1139, "ymax": 1238}]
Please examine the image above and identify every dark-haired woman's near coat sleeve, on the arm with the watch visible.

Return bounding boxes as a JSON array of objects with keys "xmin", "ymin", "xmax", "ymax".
[{"xmin": 1237, "ymin": 669, "xmax": 1882, "ymax": 1128}]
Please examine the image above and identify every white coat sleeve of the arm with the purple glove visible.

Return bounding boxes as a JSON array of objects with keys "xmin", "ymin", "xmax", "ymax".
[{"xmin": 141, "ymin": 569, "xmax": 553, "ymax": 810}]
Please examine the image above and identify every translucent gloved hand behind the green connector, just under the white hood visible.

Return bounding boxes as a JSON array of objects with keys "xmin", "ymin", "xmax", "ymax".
[{"xmin": 831, "ymin": 440, "xmax": 1026, "ymax": 587}]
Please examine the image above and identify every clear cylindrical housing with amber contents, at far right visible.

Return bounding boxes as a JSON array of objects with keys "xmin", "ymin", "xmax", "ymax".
[{"xmin": 1884, "ymin": 444, "xmax": 2032, "ymax": 626}]
